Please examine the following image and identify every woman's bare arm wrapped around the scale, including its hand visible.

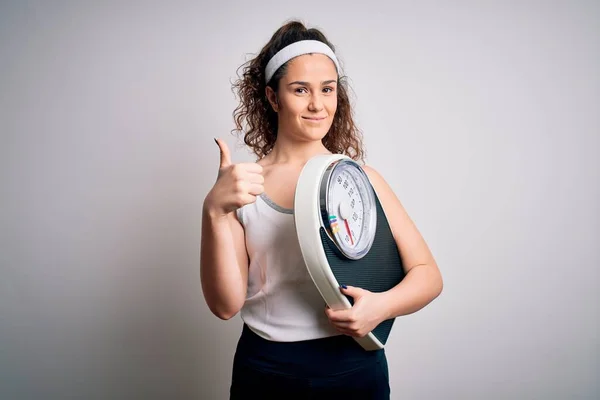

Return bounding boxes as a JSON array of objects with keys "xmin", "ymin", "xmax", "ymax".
[{"xmin": 325, "ymin": 166, "xmax": 443, "ymax": 337}]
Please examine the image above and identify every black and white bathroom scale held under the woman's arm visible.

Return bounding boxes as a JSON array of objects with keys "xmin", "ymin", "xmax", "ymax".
[{"xmin": 294, "ymin": 154, "xmax": 405, "ymax": 350}]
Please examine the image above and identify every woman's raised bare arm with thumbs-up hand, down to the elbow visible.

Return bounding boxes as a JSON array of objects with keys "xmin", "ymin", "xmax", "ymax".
[{"xmin": 200, "ymin": 139, "xmax": 264, "ymax": 319}]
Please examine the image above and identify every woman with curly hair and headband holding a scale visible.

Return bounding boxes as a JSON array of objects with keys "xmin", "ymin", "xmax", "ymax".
[{"xmin": 201, "ymin": 21, "xmax": 442, "ymax": 399}]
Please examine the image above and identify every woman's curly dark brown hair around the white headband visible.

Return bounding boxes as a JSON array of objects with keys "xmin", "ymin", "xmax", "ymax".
[{"xmin": 232, "ymin": 21, "xmax": 365, "ymax": 161}]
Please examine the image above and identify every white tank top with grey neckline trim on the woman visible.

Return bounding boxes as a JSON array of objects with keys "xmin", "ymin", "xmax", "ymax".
[{"xmin": 237, "ymin": 194, "xmax": 340, "ymax": 342}]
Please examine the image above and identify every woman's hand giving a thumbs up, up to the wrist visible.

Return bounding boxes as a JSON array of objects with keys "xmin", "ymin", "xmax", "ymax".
[{"xmin": 204, "ymin": 139, "xmax": 265, "ymax": 216}]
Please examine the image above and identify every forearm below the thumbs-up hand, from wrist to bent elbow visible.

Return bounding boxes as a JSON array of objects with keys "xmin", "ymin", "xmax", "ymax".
[{"xmin": 200, "ymin": 208, "xmax": 247, "ymax": 319}]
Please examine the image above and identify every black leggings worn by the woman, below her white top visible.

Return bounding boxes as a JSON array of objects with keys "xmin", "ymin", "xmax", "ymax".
[{"xmin": 230, "ymin": 325, "xmax": 390, "ymax": 400}]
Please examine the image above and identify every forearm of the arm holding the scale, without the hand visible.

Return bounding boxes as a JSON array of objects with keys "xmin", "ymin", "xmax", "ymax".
[{"xmin": 382, "ymin": 264, "xmax": 443, "ymax": 319}]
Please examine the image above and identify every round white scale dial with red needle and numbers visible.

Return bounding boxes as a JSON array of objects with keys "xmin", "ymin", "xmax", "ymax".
[{"xmin": 321, "ymin": 160, "xmax": 377, "ymax": 260}]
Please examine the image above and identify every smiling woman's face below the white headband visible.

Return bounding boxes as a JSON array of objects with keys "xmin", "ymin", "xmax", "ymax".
[{"xmin": 267, "ymin": 54, "xmax": 338, "ymax": 141}]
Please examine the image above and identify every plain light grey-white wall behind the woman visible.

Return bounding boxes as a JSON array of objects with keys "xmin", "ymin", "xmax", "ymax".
[{"xmin": 0, "ymin": 0, "xmax": 600, "ymax": 399}]
